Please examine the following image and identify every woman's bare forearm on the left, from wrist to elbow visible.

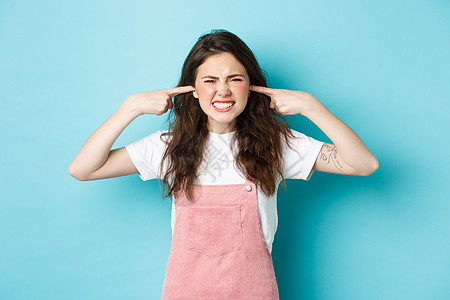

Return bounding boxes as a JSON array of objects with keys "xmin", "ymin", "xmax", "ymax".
[{"xmin": 69, "ymin": 98, "xmax": 139, "ymax": 178}]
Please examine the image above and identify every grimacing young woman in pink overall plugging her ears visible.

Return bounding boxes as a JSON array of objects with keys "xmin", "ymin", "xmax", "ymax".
[{"xmin": 69, "ymin": 30, "xmax": 378, "ymax": 299}]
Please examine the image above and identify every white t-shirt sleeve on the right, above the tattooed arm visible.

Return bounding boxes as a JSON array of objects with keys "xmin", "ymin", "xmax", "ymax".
[{"xmin": 283, "ymin": 129, "xmax": 324, "ymax": 180}]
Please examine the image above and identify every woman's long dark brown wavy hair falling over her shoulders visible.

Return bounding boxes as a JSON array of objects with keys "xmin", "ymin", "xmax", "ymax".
[{"xmin": 160, "ymin": 30, "xmax": 293, "ymax": 200}]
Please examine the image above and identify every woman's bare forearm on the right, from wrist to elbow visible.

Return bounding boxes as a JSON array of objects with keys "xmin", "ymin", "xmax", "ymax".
[{"xmin": 305, "ymin": 101, "xmax": 378, "ymax": 174}]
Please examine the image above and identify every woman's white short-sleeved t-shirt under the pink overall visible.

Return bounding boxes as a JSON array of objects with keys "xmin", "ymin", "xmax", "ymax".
[{"xmin": 125, "ymin": 129, "xmax": 323, "ymax": 252}]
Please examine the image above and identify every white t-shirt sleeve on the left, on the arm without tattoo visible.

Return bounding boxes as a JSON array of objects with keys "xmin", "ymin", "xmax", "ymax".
[{"xmin": 125, "ymin": 130, "xmax": 166, "ymax": 181}]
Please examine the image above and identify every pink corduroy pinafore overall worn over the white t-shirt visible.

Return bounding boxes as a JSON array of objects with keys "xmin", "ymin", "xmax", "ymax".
[{"xmin": 161, "ymin": 180, "xmax": 279, "ymax": 300}]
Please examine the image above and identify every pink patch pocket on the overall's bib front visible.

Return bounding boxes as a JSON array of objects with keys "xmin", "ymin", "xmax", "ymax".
[{"xmin": 187, "ymin": 205, "xmax": 242, "ymax": 257}]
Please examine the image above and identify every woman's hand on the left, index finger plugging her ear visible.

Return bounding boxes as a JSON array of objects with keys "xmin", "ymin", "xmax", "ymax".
[{"xmin": 127, "ymin": 85, "xmax": 195, "ymax": 116}]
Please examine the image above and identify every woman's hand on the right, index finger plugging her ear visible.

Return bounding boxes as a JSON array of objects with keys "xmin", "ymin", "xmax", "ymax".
[{"xmin": 250, "ymin": 85, "xmax": 321, "ymax": 115}]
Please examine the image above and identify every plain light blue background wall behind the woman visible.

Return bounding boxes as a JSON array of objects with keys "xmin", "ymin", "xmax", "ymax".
[{"xmin": 0, "ymin": 0, "xmax": 450, "ymax": 300}]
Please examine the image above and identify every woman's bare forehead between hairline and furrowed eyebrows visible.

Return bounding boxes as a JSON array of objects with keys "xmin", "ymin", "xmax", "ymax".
[{"xmin": 197, "ymin": 52, "xmax": 247, "ymax": 77}]
